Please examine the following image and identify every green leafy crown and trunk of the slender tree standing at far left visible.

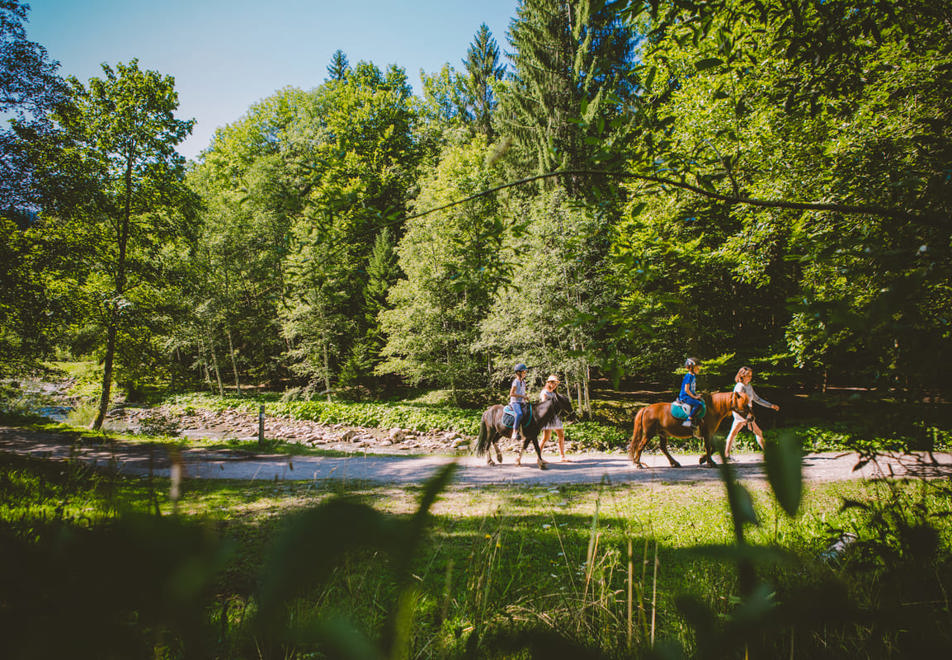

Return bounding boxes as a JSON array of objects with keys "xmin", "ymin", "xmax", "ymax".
[{"xmin": 32, "ymin": 60, "xmax": 195, "ymax": 428}]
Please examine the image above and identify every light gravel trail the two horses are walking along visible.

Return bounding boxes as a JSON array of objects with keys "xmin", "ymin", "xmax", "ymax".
[{"xmin": 0, "ymin": 426, "xmax": 952, "ymax": 485}]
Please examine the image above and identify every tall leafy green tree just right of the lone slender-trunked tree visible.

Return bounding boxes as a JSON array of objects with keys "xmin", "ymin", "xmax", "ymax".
[{"xmin": 188, "ymin": 87, "xmax": 318, "ymax": 392}]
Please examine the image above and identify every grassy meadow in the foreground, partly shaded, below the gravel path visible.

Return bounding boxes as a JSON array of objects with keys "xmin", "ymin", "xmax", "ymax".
[{"xmin": 0, "ymin": 440, "xmax": 952, "ymax": 658}]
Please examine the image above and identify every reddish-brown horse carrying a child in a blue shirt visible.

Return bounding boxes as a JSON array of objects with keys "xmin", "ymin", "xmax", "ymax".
[{"xmin": 628, "ymin": 392, "xmax": 751, "ymax": 468}]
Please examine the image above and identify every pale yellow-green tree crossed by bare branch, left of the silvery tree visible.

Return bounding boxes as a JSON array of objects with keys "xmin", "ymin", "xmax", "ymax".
[{"xmin": 377, "ymin": 136, "xmax": 509, "ymax": 394}]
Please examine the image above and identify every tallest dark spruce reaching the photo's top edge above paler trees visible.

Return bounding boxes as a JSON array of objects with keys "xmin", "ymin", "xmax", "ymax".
[{"xmin": 497, "ymin": 0, "xmax": 633, "ymax": 199}]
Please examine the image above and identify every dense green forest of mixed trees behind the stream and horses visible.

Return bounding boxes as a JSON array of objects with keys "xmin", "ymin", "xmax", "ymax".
[{"xmin": 0, "ymin": 0, "xmax": 952, "ymax": 423}]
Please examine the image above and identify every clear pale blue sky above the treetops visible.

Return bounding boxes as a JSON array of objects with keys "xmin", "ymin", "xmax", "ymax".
[{"xmin": 26, "ymin": 0, "xmax": 519, "ymax": 158}]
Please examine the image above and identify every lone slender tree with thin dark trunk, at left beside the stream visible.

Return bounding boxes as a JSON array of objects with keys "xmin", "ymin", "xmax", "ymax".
[{"xmin": 51, "ymin": 60, "xmax": 194, "ymax": 429}]
